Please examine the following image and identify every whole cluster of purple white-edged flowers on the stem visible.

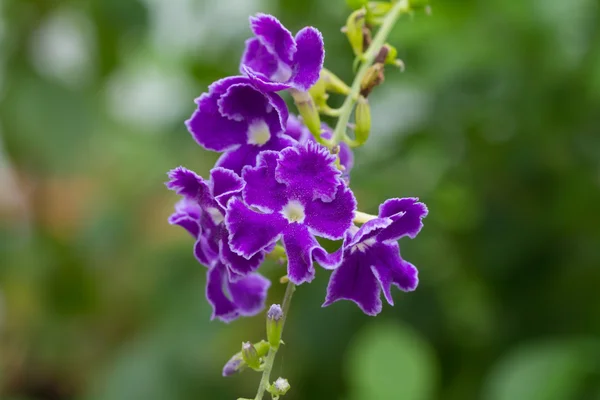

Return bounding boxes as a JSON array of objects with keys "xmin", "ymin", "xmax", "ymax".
[{"xmin": 167, "ymin": 14, "xmax": 427, "ymax": 322}]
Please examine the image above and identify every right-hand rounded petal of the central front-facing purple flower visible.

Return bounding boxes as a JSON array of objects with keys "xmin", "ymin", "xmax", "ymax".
[{"xmin": 304, "ymin": 184, "xmax": 356, "ymax": 240}]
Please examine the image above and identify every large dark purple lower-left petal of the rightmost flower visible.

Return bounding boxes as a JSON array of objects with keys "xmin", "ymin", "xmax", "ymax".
[{"xmin": 323, "ymin": 251, "xmax": 382, "ymax": 316}]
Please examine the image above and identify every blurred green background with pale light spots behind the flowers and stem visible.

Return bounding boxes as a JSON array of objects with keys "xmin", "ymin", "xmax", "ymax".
[{"xmin": 0, "ymin": 0, "xmax": 600, "ymax": 400}]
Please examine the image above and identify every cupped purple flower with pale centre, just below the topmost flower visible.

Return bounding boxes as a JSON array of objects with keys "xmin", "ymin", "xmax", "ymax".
[{"xmin": 186, "ymin": 76, "xmax": 294, "ymax": 174}]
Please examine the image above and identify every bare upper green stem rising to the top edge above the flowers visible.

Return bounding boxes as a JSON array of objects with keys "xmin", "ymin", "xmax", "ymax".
[{"xmin": 328, "ymin": 0, "xmax": 410, "ymax": 147}]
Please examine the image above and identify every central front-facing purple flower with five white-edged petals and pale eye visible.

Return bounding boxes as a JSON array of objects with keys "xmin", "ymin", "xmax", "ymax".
[{"xmin": 225, "ymin": 143, "xmax": 356, "ymax": 284}]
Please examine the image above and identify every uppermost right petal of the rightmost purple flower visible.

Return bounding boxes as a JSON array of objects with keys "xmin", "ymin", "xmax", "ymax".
[{"xmin": 377, "ymin": 197, "xmax": 428, "ymax": 241}]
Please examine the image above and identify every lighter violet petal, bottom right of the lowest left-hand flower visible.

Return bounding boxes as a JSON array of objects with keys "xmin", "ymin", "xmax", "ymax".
[{"xmin": 229, "ymin": 274, "xmax": 271, "ymax": 316}]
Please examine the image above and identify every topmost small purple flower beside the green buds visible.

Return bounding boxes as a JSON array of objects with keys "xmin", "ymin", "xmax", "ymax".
[{"xmin": 240, "ymin": 14, "xmax": 325, "ymax": 91}]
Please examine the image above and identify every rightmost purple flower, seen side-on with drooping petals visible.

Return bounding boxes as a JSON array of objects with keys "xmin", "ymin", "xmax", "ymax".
[{"xmin": 323, "ymin": 198, "xmax": 427, "ymax": 315}]
